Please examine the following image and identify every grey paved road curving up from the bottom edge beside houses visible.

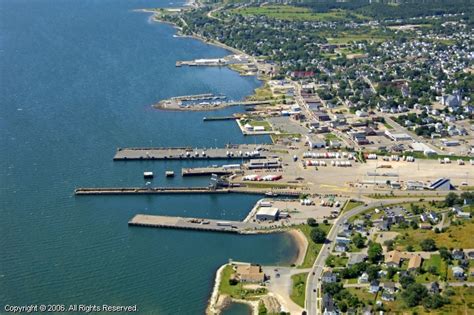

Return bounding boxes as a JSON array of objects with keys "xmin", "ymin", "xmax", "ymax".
[{"xmin": 305, "ymin": 198, "xmax": 444, "ymax": 315}]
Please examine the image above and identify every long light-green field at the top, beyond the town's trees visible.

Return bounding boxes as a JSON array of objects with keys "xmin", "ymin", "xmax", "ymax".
[{"xmin": 231, "ymin": 5, "xmax": 368, "ymax": 21}]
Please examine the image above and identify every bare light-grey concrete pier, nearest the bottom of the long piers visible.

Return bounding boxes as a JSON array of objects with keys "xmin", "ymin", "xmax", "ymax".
[{"xmin": 128, "ymin": 214, "xmax": 258, "ymax": 234}]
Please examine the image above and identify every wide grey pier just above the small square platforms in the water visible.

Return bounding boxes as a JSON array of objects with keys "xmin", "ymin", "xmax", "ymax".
[{"xmin": 114, "ymin": 145, "xmax": 266, "ymax": 161}]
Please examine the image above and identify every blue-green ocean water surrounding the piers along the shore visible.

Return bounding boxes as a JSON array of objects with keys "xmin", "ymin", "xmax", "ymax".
[{"xmin": 0, "ymin": 0, "xmax": 294, "ymax": 314}]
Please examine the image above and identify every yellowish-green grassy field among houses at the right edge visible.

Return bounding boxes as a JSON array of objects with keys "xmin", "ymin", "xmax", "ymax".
[{"xmin": 396, "ymin": 220, "xmax": 474, "ymax": 250}]
